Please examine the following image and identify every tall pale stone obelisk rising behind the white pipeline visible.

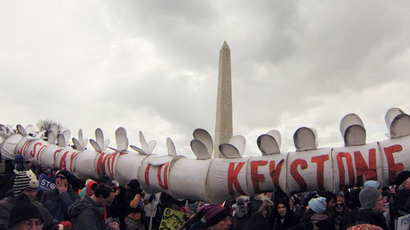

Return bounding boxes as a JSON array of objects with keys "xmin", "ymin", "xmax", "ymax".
[{"xmin": 214, "ymin": 41, "xmax": 232, "ymax": 158}]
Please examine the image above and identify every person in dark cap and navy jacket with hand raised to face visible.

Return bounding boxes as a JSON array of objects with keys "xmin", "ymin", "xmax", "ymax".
[{"xmin": 41, "ymin": 170, "xmax": 80, "ymax": 221}]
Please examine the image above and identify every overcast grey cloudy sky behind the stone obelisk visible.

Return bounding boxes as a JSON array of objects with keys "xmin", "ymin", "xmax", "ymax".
[{"xmin": 0, "ymin": 0, "xmax": 410, "ymax": 157}]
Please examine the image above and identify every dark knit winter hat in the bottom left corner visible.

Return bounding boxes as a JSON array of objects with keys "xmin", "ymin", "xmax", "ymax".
[{"xmin": 9, "ymin": 193, "xmax": 43, "ymax": 228}]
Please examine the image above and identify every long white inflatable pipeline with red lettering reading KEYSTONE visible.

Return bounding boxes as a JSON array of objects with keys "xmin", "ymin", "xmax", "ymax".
[{"xmin": 1, "ymin": 108, "xmax": 410, "ymax": 203}]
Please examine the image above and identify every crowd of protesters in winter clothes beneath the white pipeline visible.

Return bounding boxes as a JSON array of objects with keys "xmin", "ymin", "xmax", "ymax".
[{"xmin": 0, "ymin": 155, "xmax": 410, "ymax": 230}]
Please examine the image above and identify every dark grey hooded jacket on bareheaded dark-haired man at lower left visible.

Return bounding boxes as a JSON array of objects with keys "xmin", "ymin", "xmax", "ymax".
[{"xmin": 67, "ymin": 196, "xmax": 104, "ymax": 230}]
